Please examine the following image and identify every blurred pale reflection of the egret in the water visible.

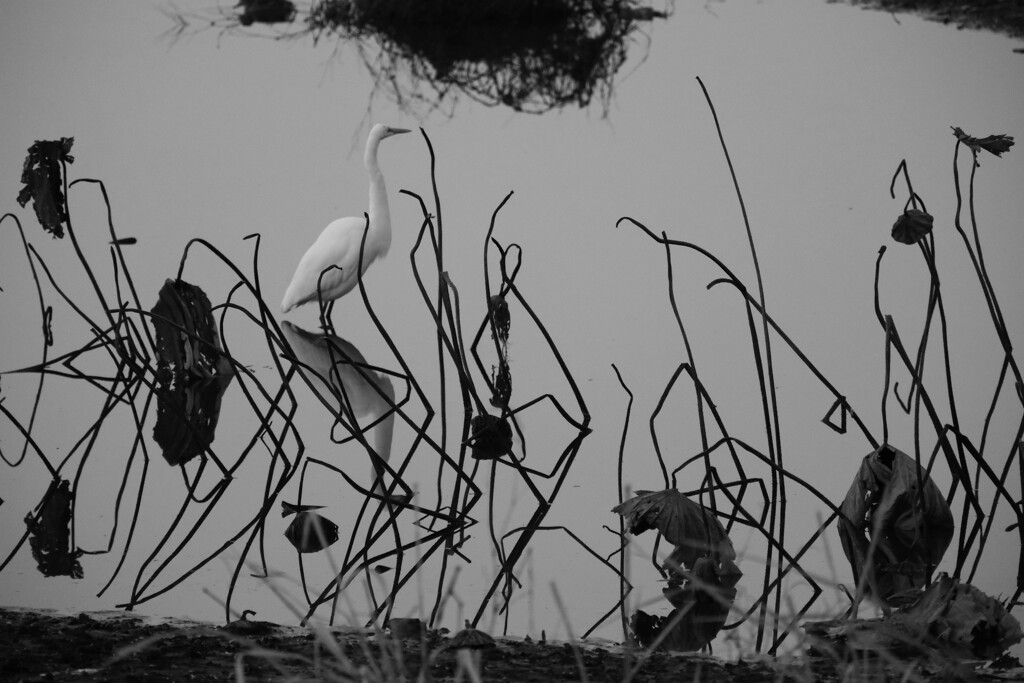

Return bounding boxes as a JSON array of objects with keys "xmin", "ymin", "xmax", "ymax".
[{"xmin": 282, "ymin": 321, "xmax": 404, "ymax": 493}]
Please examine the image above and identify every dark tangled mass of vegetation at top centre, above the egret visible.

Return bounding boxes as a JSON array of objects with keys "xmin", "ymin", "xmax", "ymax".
[{"xmin": 166, "ymin": 0, "xmax": 668, "ymax": 113}]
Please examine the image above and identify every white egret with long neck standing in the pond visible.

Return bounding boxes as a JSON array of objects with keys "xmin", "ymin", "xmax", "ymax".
[{"xmin": 281, "ymin": 123, "xmax": 409, "ymax": 313}]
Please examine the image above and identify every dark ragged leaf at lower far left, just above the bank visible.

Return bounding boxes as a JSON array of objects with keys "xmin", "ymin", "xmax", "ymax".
[{"xmin": 25, "ymin": 479, "xmax": 84, "ymax": 579}]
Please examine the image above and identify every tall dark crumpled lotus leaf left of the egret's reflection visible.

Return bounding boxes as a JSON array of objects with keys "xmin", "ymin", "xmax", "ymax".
[{"xmin": 151, "ymin": 280, "xmax": 234, "ymax": 465}]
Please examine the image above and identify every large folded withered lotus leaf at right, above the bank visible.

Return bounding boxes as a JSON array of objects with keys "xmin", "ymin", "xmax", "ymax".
[{"xmin": 839, "ymin": 445, "xmax": 953, "ymax": 604}]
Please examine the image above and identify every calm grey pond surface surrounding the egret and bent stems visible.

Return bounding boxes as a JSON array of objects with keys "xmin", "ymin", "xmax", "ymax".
[{"xmin": 0, "ymin": 0, "xmax": 1024, "ymax": 653}]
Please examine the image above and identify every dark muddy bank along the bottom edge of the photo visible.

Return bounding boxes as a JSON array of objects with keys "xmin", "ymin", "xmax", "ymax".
[{"xmin": 6, "ymin": 608, "xmax": 1024, "ymax": 683}]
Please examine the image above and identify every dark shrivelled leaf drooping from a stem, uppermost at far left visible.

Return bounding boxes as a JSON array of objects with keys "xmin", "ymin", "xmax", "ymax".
[{"xmin": 17, "ymin": 137, "xmax": 75, "ymax": 238}]
